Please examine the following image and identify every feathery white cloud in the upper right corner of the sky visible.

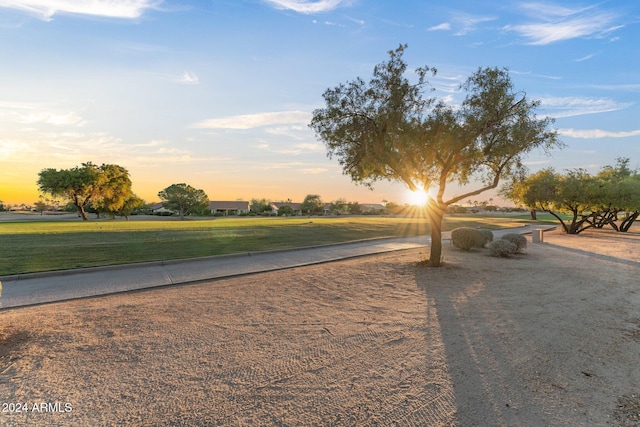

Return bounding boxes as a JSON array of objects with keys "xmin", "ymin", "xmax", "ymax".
[{"xmin": 503, "ymin": 3, "xmax": 622, "ymax": 45}]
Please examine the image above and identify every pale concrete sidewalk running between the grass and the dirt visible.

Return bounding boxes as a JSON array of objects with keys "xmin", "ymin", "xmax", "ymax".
[{"xmin": 0, "ymin": 226, "xmax": 549, "ymax": 309}]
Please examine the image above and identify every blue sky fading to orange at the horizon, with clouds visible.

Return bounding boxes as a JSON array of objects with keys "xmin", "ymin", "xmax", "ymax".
[{"xmin": 0, "ymin": 0, "xmax": 640, "ymax": 204}]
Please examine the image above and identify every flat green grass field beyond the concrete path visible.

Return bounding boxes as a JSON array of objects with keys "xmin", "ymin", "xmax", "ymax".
[{"xmin": 0, "ymin": 216, "xmax": 540, "ymax": 276}]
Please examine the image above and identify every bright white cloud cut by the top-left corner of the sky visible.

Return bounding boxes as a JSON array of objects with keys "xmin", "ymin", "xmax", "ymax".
[{"xmin": 0, "ymin": 0, "xmax": 162, "ymax": 21}]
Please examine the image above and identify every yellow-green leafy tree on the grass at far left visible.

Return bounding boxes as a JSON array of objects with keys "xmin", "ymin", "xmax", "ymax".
[{"xmin": 38, "ymin": 162, "xmax": 131, "ymax": 221}]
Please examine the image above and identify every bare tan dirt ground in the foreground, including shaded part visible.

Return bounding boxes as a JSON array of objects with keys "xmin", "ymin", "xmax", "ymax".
[{"xmin": 0, "ymin": 230, "xmax": 640, "ymax": 426}]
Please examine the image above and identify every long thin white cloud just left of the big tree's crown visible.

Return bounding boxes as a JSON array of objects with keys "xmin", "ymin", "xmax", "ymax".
[{"xmin": 191, "ymin": 111, "xmax": 311, "ymax": 129}]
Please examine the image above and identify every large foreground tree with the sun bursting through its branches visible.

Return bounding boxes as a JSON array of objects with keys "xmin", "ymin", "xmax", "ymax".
[{"xmin": 310, "ymin": 45, "xmax": 559, "ymax": 266}]
